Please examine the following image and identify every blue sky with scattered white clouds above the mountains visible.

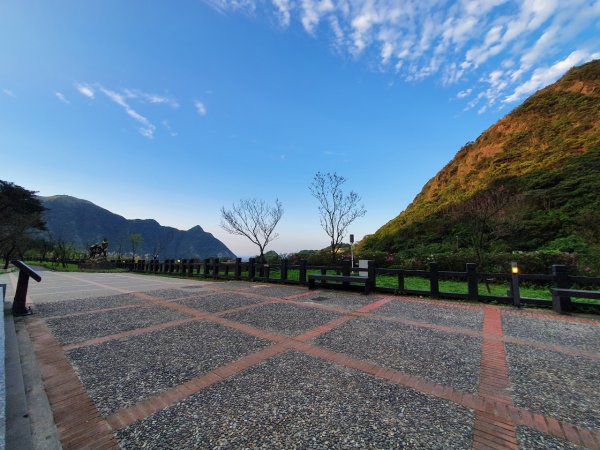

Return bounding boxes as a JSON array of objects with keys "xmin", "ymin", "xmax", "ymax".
[{"xmin": 0, "ymin": 0, "xmax": 600, "ymax": 255}]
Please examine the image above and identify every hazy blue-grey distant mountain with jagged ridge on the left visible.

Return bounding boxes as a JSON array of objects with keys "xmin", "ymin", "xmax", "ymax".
[{"xmin": 40, "ymin": 195, "xmax": 235, "ymax": 259}]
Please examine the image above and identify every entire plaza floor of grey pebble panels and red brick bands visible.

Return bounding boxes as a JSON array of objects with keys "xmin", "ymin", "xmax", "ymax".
[{"xmin": 0, "ymin": 271, "xmax": 600, "ymax": 449}]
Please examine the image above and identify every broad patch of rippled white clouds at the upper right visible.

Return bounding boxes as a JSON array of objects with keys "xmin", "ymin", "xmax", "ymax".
[{"xmin": 206, "ymin": 0, "xmax": 600, "ymax": 112}]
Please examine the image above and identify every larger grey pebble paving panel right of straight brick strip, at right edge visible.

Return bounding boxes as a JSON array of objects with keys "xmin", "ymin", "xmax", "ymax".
[{"xmin": 505, "ymin": 344, "xmax": 600, "ymax": 428}]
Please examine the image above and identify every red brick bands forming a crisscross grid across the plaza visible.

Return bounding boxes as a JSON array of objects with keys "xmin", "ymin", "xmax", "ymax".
[{"xmin": 18, "ymin": 275, "xmax": 600, "ymax": 449}]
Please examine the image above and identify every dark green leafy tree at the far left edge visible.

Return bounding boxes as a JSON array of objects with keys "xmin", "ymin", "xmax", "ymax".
[{"xmin": 0, "ymin": 180, "xmax": 46, "ymax": 268}]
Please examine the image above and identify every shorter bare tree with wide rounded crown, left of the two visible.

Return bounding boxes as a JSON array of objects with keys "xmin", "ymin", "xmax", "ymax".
[{"xmin": 221, "ymin": 198, "xmax": 283, "ymax": 262}]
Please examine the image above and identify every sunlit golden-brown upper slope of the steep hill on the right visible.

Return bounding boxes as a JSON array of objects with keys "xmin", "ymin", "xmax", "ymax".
[{"xmin": 361, "ymin": 60, "xmax": 600, "ymax": 255}]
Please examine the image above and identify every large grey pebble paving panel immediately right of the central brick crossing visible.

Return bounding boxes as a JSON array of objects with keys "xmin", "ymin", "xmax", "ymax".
[{"xmin": 314, "ymin": 318, "xmax": 481, "ymax": 393}]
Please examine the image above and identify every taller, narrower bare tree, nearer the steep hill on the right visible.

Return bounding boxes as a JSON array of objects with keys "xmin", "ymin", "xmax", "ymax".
[{"xmin": 309, "ymin": 172, "xmax": 367, "ymax": 261}]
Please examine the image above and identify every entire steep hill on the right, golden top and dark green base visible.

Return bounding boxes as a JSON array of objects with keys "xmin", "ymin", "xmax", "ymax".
[{"xmin": 361, "ymin": 60, "xmax": 600, "ymax": 252}]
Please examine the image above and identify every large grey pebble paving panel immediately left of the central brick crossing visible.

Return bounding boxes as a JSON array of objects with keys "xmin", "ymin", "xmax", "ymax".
[{"xmin": 67, "ymin": 321, "xmax": 271, "ymax": 414}]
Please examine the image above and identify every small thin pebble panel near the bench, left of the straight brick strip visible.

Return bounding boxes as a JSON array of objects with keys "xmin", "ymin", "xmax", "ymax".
[{"xmin": 374, "ymin": 300, "xmax": 483, "ymax": 331}]
